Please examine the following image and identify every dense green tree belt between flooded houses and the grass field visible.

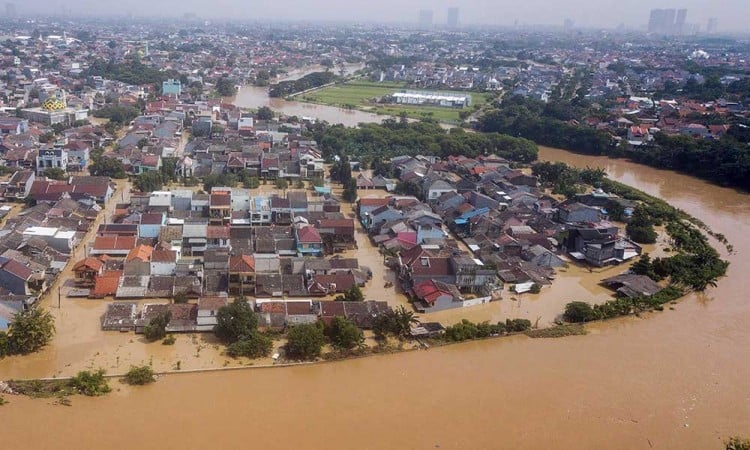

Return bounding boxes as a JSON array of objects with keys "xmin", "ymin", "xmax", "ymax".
[{"xmin": 312, "ymin": 119, "xmax": 538, "ymax": 163}]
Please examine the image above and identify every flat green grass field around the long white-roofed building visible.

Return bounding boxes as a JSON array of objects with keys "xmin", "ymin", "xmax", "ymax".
[{"xmin": 296, "ymin": 80, "xmax": 500, "ymax": 123}]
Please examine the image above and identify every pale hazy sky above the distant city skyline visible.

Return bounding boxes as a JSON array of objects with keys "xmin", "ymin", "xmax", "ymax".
[{"xmin": 14, "ymin": 0, "xmax": 750, "ymax": 31}]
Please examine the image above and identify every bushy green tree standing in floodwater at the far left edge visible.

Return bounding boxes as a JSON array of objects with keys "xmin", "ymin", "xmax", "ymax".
[{"xmin": 7, "ymin": 307, "xmax": 55, "ymax": 355}]
